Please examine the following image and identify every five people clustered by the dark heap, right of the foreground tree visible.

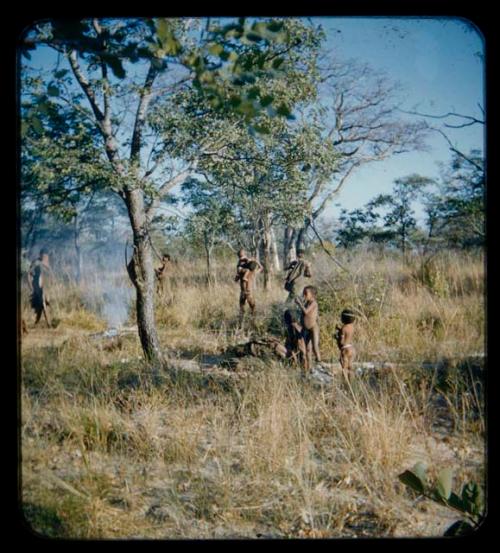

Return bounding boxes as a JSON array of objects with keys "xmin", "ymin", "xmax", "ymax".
[{"xmin": 234, "ymin": 249, "xmax": 355, "ymax": 379}]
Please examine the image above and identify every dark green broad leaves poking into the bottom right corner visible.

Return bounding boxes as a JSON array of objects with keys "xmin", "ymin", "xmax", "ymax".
[{"xmin": 399, "ymin": 463, "xmax": 485, "ymax": 536}]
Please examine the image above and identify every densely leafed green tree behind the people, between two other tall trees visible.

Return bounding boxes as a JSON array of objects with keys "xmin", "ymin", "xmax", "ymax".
[{"xmin": 152, "ymin": 22, "xmax": 335, "ymax": 286}]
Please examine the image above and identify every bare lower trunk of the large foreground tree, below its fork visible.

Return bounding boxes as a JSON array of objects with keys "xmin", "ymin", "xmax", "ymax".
[{"xmin": 125, "ymin": 189, "xmax": 163, "ymax": 363}]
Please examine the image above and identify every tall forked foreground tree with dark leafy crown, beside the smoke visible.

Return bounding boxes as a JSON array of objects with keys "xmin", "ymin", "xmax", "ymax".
[{"xmin": 23, "ymin": 18, "xmax": 316, "ymax": 362}]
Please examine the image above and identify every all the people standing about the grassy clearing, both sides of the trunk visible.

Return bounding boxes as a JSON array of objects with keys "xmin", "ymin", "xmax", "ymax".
[{"xmin": 23, "ymin": 248, "xmax": 355, "ymax": 377}]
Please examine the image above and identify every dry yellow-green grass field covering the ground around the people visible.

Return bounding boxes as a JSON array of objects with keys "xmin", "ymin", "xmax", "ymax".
[{"xmin": 20, "ymin": 253, "xmax": 486, "ymax": 539}]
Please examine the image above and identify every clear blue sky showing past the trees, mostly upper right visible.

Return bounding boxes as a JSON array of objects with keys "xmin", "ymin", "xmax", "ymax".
[{"xmin": 20, "ymin": 17, "xmax": 485, "ymax": 226}]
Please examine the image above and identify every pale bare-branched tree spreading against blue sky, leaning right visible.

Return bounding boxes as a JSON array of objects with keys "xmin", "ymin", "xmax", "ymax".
[{"xmin": 284, "ymin": 56, "xmax": 428, "ymax": 257}]
